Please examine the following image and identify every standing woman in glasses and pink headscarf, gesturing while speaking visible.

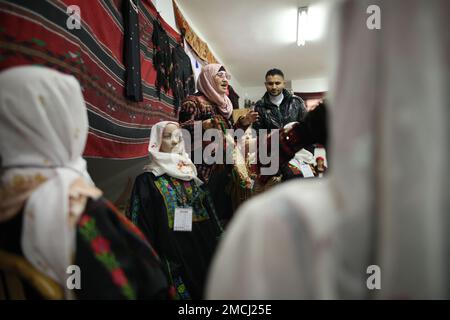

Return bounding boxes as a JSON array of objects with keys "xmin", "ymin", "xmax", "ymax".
[{"xmin": 179, "ymin": 64, "xmax": 258, "ymax": 225}]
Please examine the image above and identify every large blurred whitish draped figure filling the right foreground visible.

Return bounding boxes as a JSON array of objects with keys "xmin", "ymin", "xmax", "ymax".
[{"xmin": 207, "ymin": 0, "xmax": 450, "ymax": 299}]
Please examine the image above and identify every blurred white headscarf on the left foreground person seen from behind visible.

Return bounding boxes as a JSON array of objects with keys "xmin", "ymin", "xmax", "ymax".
[{"xmin": 0, "ymin": 66, "xmax": 99, "ymax": 287}]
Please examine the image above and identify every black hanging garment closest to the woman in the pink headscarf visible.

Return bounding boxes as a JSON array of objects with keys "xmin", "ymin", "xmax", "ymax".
[{"xmin": 170, "ymin": 45, "xmax": 195, "ymax": 112}]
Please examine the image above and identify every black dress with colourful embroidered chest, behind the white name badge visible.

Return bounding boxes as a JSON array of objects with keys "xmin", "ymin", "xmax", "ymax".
[{"xmin": 129, "ymin": 172, "xmax": 222, "ymax": 299}]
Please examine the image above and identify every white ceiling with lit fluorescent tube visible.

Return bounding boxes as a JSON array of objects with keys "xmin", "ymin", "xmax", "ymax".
[{"xmin": 176, "ymin": 0, "xmax": 332, "ymax": 86}]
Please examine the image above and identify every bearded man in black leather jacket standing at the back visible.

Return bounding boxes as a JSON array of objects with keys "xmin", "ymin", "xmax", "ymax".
[{"xmin": 253, "ymin": 69, "xmax": 307, "ymax": 132}]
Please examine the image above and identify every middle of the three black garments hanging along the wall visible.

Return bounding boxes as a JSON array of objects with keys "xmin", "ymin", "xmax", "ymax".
[{"xmin": 152, "ymin": 20, "xmax": 172, "ymax": 100}]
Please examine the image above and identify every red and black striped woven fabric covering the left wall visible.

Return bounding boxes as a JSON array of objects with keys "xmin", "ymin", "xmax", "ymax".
[{"xmin": 0, "ymin": 0, "xmax": 179, "ymax": 159}]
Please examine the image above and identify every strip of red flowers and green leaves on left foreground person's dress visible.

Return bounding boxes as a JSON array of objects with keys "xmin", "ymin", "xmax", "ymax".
[{"xmin": 78, "ymin": 214, "xmax": 136, "ymax": 300}]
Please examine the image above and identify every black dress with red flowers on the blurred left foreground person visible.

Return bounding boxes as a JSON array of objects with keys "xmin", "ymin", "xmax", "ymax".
[{"xmin": 0, "ymin": 199, "xmax": 169, "ymax": 300}]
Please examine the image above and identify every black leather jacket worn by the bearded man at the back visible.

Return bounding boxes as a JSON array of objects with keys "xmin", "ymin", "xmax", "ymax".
[{"xmin": 253, "ymin": 89, "xmax": 307, "ymax": 131}]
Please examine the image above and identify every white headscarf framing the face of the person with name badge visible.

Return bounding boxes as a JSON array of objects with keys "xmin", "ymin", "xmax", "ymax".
[{"xmin": 144, "ymin": 121, "xmax": 203, "ymax": 184}]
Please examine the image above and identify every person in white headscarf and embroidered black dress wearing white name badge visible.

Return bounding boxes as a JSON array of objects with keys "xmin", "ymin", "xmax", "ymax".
[{"xmin": 128, "ymin": 121, "xmax": 222, "ymax": 299}]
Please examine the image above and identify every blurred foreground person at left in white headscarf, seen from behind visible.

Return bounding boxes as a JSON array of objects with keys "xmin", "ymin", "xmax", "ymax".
[{"xmin": 0, "ymin": 66, "xmax": 168, "ymax": 299}]
